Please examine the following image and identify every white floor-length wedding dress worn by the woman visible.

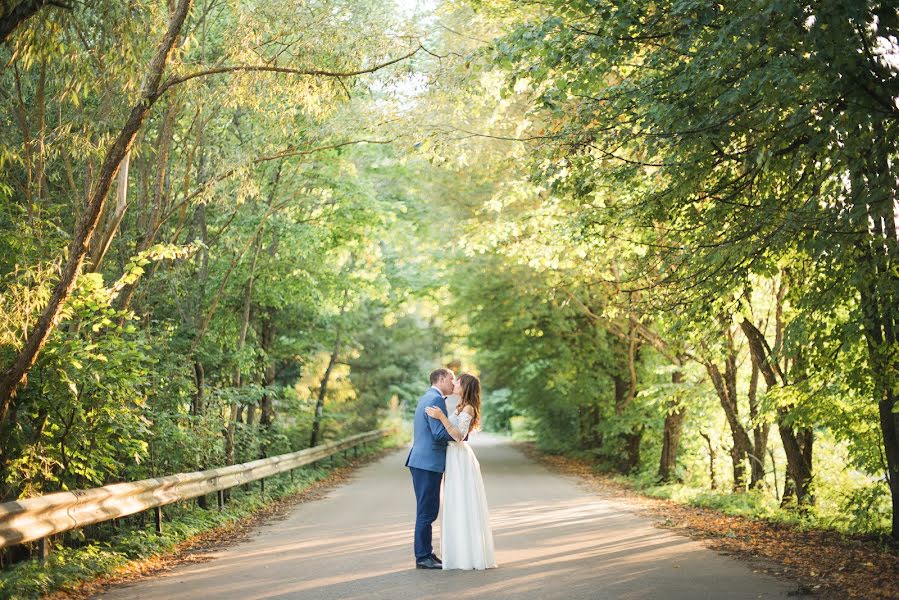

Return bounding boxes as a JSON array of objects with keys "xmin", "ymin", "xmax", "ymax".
[{"xmin": 440, "ymin": 411, "xmax": 496, "ymax": 570}]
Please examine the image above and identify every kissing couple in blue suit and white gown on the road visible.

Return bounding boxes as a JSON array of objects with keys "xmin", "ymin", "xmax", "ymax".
[{"xmin": 406, "ymin": 369, "xmax": 496, "ymax": 570}]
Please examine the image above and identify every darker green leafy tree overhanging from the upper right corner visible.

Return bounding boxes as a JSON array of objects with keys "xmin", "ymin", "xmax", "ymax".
[{"xmin": 486, "ymin": 1, "xmax": 899, "ymax": 537}]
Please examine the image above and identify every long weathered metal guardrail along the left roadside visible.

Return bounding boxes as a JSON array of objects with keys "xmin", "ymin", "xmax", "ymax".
[{"xmin": 0, "ymin": 429, "xmax": 390, "ymax": 553}]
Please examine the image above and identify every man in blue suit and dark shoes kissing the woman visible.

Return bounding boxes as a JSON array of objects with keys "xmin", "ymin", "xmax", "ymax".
[{"xmin": 406, "ymin": 369, "xmax": 454, "ymax": 569}]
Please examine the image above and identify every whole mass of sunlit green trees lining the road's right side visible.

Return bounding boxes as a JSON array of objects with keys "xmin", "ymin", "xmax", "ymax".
[{"xmin": 402, "ymin": 0, "xmax": 899, "ymax": 535}]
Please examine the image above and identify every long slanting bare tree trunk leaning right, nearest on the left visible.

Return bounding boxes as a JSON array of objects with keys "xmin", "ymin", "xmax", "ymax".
[{"xmin": 0, "ymin": 0, "xmax": 191, "ymax": 423}]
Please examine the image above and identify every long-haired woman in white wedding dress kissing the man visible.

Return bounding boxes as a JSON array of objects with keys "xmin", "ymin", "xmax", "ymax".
[{"xmin": 425, "ymin": 373, "xmax": 496, "ymax": 570}]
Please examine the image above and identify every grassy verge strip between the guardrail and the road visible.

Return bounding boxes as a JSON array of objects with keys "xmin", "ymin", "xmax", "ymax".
[{"xmin": 0, "ymin": 436, "xmax": 401, "ymax": 600}]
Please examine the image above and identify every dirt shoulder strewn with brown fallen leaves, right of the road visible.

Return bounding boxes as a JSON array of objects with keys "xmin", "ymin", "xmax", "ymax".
[{"xmin": 518, "ymin": 443, "xmax": 899, "ymax": 600}]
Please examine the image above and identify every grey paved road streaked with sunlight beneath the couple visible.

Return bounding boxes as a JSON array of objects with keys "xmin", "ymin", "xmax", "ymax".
[{"xmin": 101, "ymin": 434, "xmax": 796, "ymax": 600}]
